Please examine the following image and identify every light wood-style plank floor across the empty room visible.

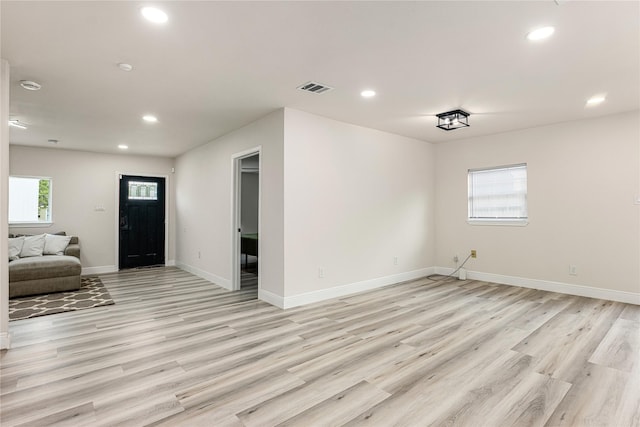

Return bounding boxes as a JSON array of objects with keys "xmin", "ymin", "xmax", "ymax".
[{"xmin": 0, "ymin": 268, "xmax": 640, "ymax": 427}]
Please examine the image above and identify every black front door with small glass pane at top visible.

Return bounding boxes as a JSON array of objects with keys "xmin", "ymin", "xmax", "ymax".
[{"xmin": 119, "ymin": 175, "xmax": 165, "ymax": 268}]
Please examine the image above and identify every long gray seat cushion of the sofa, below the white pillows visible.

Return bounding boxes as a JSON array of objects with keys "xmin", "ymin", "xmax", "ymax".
[{"xmin": 9, "ymin": 255, "xmax": 82, "ymax": 282}]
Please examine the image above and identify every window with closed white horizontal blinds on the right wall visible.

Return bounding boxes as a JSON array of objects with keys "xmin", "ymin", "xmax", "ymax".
[{"xmin": 469, "ymin": 164, "xmax": 528, "ymax": 225}]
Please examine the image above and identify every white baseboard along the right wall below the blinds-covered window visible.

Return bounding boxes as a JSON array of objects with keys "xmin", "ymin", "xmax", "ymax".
[{"xmin": 435, "ymin": 267, "xmax": 640, "ymax": 305}]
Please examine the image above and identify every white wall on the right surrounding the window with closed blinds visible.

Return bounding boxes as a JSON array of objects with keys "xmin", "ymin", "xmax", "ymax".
[{"xmin": 436, "ymin": 111, "xmax": 640, "ymax": 302}]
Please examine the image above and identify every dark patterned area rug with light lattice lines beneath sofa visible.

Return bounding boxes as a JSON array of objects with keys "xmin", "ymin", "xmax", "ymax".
[{"xmin": 9, "ymin": 276, "xmax": 115, "ymax": 320}]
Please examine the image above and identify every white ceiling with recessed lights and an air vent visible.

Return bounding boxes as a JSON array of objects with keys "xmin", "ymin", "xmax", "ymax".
[{"xmin": 0, "ymin": 0, "xmax": 640, "ymax": 157}]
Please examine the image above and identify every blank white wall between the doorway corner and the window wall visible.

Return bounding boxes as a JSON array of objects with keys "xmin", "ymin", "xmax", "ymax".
[{"xmin": 284, "ymin": 108, "xmax": 435, "ymax": 306}]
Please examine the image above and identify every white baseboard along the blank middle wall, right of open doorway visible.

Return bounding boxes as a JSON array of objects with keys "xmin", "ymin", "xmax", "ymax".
[{"xmin": 280, "ymin": 267, "xmax": 435, "ymax": 309}]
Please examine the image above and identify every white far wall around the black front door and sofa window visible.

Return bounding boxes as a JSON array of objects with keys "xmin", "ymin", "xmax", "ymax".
[{"xmin": 9, "ymin": 145, "xmax": 175, "ymax": 274}]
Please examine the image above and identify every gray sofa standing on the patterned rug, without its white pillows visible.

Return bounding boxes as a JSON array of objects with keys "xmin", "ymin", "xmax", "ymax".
[{"xmin": 9, "ymin": 233, "xmax": 82, "ymax": 298}]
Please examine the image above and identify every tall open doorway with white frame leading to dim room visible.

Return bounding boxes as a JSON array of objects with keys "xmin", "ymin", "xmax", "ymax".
[{"xmin": 232, "ymin": 149, "xmax": 260, "ymax": 295}]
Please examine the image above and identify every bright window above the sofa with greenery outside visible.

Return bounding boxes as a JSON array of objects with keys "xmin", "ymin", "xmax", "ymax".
[{"xmin": 9, "ymin": 176, "xmax": 52, "ymax": 224}]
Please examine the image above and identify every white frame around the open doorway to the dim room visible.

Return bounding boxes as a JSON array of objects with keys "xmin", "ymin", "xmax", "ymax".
[{"xmin": 231, "ymin": 145, "xmax": 262, "ymax": 291}]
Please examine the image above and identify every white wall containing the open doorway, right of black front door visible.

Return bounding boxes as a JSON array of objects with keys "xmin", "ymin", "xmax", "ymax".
[{"xmin": 176, "ymin": 110, "xmax": 284, "ymax": 296}]
